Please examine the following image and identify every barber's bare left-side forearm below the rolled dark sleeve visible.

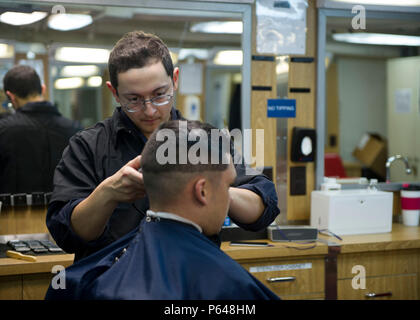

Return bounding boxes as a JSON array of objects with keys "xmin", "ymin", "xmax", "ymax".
[{"xmin": 71, "ymin": 184, "xmax": 118, "ymax": 241}]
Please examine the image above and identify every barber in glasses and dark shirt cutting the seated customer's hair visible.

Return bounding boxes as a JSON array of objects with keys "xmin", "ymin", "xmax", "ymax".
[{"xmin": 47, "ymin": 31, "xmax": 279, "ymax": 260}]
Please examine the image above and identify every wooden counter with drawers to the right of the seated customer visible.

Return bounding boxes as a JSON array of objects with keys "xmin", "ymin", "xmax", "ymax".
[{"xmin": 222, "ymin": 223, "xmax": 420, "ymax": 300}]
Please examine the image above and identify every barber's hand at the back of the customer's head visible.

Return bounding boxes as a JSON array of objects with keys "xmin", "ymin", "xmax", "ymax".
[{"xmin": 103, "ymin": 156, "xmax": 146, "ymax": 202}]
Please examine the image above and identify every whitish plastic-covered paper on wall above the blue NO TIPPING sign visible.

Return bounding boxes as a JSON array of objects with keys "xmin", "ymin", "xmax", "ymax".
[{"xmin": 256, "ymin": 0, "xmax": 308, "ymax": 55}]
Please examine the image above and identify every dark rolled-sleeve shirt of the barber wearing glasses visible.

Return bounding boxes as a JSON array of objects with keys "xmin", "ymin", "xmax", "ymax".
[{"xmin": 47, "ymin": 107, "xmax": 279, "ymax": 260}]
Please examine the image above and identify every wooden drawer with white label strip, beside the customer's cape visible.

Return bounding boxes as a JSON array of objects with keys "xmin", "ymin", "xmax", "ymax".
[{"xmin": 242, "ymin": 258, "xmax": 325, "ymax": 298}]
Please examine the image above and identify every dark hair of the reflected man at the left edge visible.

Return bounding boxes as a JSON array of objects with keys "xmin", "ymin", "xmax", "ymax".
[{"xmin": 3, "ymin": 65, "xmax": 42, "ymax": 99}]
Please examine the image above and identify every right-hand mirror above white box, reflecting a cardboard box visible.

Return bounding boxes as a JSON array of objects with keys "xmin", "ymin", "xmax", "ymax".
[{"xmin": 324, "ymin": 17, "xmax": 420, "ymax": 181}]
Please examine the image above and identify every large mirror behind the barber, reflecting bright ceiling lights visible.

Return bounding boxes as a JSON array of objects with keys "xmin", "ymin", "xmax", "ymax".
[{"xmin": 0, "ymin": 0, "xmax": 251, "ymax": 192}]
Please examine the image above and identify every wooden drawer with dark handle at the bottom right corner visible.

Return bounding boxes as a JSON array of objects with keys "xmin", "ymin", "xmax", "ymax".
[{"xmin": 337, "ymin": 274, "xmax": 418, "ymax": 300}]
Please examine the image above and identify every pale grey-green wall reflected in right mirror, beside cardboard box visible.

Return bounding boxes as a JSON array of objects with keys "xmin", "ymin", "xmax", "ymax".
[{"xmin": 336, "ymin": 57, "xmax": 387, "ymax": 161}]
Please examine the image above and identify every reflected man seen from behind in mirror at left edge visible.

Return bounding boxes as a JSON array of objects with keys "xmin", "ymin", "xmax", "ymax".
[{"xmin": 0, "ymin": 65, "xmax": 83, "ymax": 194}]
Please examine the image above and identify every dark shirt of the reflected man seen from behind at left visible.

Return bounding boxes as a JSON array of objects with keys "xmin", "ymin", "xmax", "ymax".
[{"xmin": 0, "ymin": 101, "xmax": 83, "ymax": 193}]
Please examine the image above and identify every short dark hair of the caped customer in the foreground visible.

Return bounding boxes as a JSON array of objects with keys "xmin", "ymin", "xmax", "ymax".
[{"xmin": 141, "ymin": 120, "xmax": 232, "ymax": 202}]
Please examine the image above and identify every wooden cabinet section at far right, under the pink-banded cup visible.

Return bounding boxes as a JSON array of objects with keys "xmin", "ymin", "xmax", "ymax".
[{"xmin": 328, "ymin": 223, "xmax": 420, "ymax": 300}]
